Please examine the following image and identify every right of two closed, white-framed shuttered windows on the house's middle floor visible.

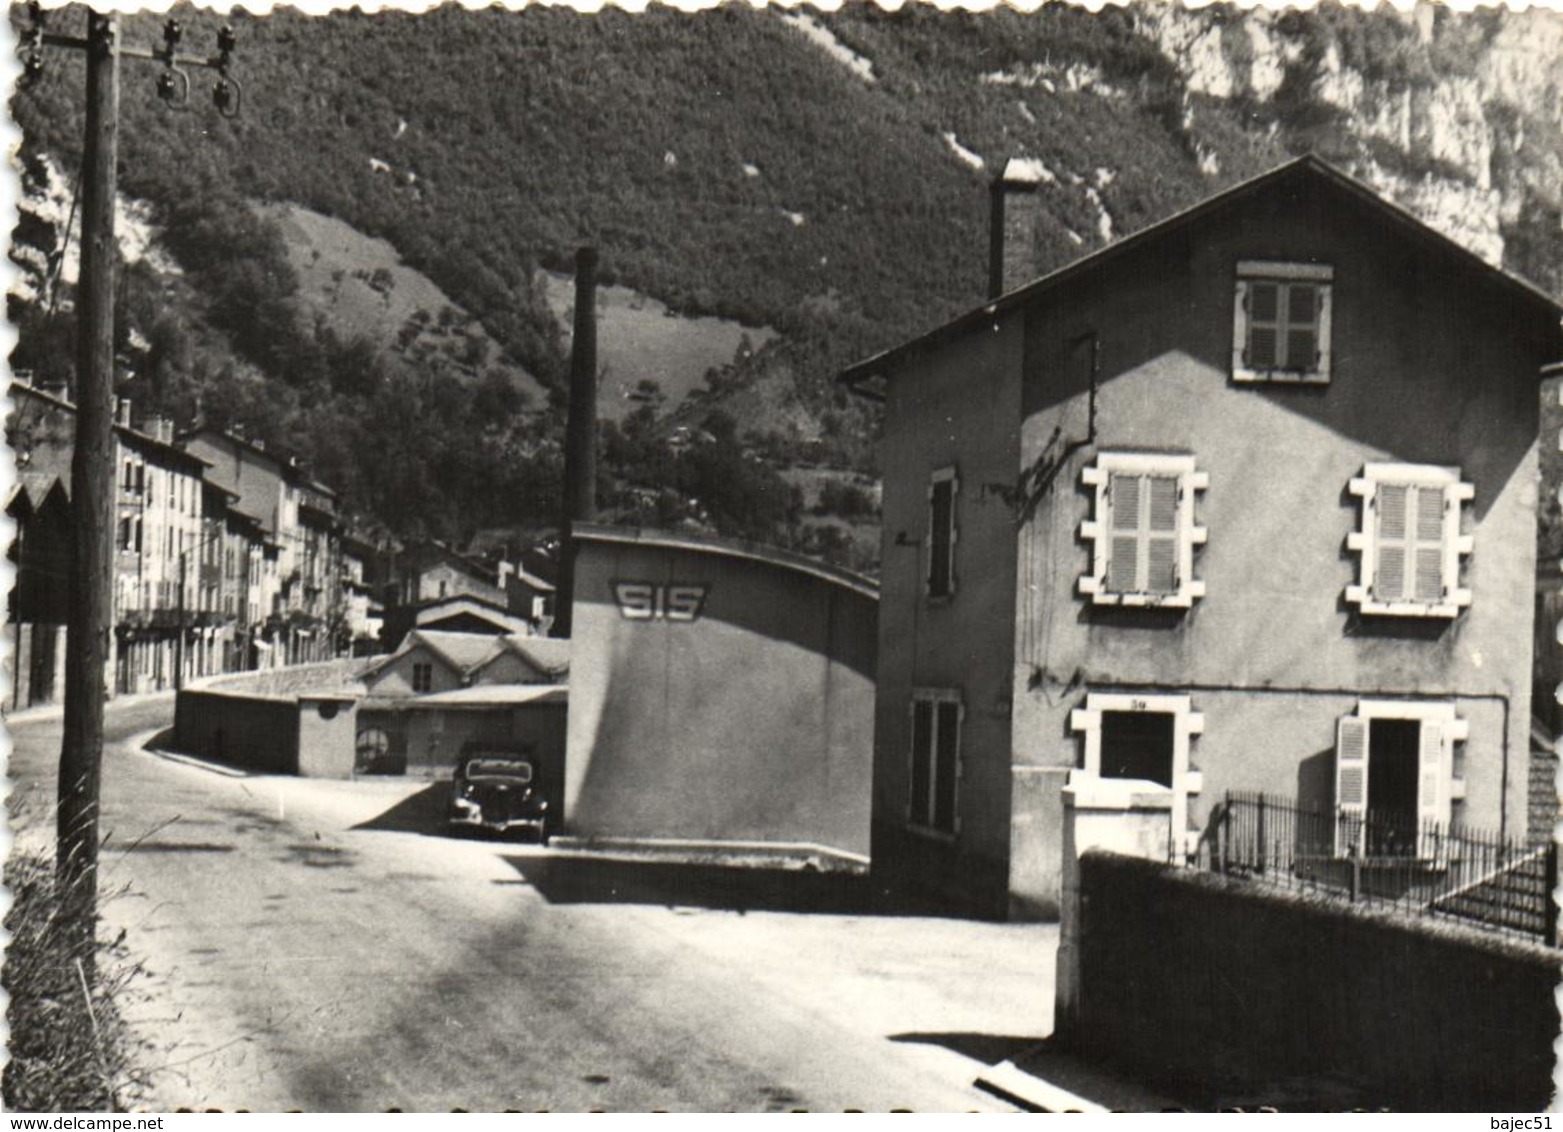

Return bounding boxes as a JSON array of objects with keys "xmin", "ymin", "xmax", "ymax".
[{"xmin": 1346, "ymin": 464, "xmax": 1475, "ymax": 618}]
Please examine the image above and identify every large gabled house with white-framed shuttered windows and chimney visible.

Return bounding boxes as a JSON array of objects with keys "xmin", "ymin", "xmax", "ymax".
[{"xmin": 842, "ymin": 156, "xmax": 1563, "ymax": 916}]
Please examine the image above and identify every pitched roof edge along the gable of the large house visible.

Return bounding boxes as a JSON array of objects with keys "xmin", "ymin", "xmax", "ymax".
[{"xmin": 836, "ymin": 153, "xmax": 1563, "ymax": 396}]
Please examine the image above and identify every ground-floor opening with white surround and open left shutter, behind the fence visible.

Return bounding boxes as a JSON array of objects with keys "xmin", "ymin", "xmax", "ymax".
[{"xmin": 1335, "ymin": 699, "xmax": 1469, "ymax": 858}]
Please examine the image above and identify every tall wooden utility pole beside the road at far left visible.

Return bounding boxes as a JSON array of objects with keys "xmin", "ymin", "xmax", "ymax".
[{"xmin": 56, "ymin": 11, "xmax": 119, "ymax": 973}]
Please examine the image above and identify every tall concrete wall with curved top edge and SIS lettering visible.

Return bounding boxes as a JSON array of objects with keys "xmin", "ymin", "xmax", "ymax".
[{"xmin": 564, "ymin": 528, "xmax": 878, "ymax": 854}]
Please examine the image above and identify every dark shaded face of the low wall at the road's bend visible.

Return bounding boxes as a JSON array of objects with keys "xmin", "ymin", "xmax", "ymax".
[{"xmin": 173, "ymin": 688, "xmax": 299, "ymax": 774}]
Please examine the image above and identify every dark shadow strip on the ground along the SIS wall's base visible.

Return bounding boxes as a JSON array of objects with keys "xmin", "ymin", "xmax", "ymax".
[{"xmin": 505, "ymin": 855, "xmax": 872, "ymax": 915}]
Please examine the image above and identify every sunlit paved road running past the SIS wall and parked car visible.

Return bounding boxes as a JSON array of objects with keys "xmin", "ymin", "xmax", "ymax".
[{"xmin": 11, "ymin": 700, "xmax": 1057, "ymax": 1112}]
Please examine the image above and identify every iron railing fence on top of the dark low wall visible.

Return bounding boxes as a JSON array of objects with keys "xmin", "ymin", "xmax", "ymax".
[{"xmin": 1191, "ymin": 793, "xmax": 1558, "ymax": 948}]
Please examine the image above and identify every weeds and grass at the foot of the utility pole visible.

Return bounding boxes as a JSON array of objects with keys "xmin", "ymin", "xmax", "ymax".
[{"xmin": 0, "ymin": 849, "xmax": 139, "ymax": 1112}]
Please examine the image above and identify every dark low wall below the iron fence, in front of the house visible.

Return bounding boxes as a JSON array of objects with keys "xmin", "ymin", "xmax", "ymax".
[{"xmin": 1071, "ymin": 852, "xmax": 1563, "ymax": 1112}]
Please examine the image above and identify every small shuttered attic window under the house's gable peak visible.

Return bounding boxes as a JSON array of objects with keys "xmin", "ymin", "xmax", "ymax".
[{"xmin": 1232, "ymin": 260, "xmax": 1335, "ymax": 383}]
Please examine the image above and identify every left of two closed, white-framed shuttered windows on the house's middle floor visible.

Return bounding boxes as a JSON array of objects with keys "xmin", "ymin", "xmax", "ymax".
[{"xmin": 1080, "ymin": 452, "xmax": 1210, "ymax": 608}]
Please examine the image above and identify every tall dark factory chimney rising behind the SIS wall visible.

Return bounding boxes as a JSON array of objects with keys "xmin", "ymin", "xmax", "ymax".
[{"xmin": 550, "ymin": 247, "xmax": 597, "ymax": 636}]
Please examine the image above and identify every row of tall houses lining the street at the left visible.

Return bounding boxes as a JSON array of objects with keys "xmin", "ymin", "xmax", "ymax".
[{"xmin": 6, "ymin": 384, "xmax": 553, "ymax": 708}]
